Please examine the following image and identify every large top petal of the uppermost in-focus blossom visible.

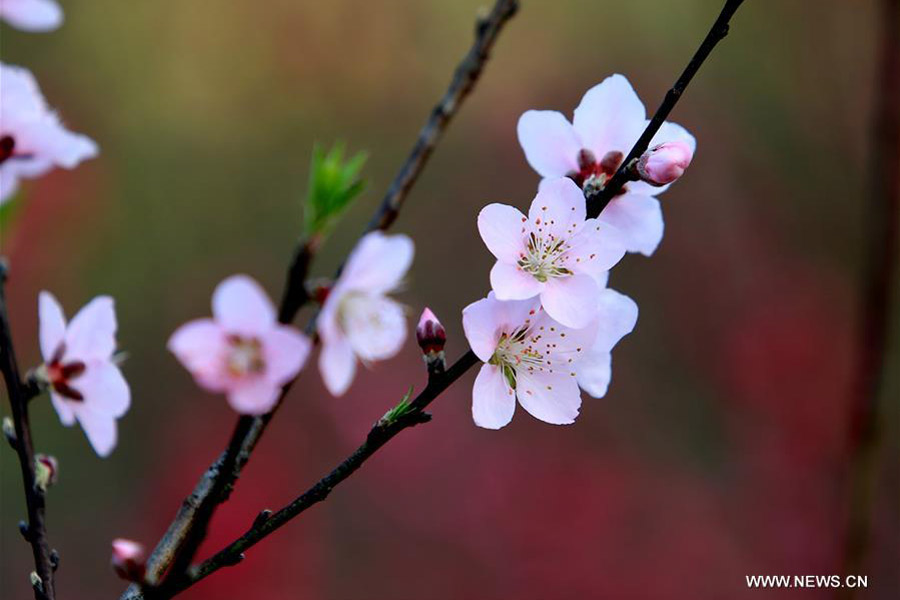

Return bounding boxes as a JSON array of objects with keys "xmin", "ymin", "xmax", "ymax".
[{"xmin": 573, "ymin": 74, "xmax": 646, "ymax": 160}]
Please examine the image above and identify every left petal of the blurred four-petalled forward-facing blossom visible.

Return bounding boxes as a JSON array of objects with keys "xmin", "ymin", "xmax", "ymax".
[{"xmin": 167, "ymin": 319, "xmax": 230, "ymax": 392}]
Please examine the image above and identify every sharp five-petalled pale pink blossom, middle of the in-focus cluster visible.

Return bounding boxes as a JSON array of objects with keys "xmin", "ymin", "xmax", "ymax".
[{"xmin": 478, "ymin": 178, "xmax": 625, "ymax": 327}]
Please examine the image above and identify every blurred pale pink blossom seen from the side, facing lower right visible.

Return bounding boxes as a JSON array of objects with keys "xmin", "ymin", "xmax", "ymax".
[{"xmin": 318, "ymin": 231, "xmax": 414, "ymax": 396}]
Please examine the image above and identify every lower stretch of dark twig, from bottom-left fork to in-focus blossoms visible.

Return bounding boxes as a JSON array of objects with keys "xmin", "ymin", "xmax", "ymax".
[{"xmin": 166, "ymin": 350, "xmax": 478, "ymax": 593}]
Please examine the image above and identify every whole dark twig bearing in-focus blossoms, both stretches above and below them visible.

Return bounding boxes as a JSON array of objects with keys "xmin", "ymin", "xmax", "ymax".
[{"xmin": 153, "ymin": 0, "xmax": 741, "ymax": 594}]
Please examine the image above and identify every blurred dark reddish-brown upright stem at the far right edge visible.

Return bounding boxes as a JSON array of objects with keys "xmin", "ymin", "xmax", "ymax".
[{"xmin": 841, "ymin": 0, "xmax": 900, "ymax": 598}]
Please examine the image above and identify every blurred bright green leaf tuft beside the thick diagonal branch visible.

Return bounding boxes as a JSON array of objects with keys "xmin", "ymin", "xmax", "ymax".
[{"xmin": 303, "ymin": 143, "xmax": 367, "ymax": 237}]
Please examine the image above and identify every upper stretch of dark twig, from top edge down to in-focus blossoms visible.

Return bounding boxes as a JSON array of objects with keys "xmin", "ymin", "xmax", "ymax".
[{"xmin": 587, "ymin": 0, "xmax": 744, "ymax": 218}]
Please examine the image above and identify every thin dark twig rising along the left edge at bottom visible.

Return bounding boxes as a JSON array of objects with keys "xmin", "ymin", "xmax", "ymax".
[{"xmin": 0, "ymin": 259, "xmax": 57, "ymax": 600}]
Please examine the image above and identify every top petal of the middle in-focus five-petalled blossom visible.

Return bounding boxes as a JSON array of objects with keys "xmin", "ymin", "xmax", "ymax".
[{"xmin": 528, "ymin": 177, "xmax": 587, "ymax": 239}]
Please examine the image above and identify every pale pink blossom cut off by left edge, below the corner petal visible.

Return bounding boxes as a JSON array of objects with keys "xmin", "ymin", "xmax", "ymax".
[{"xmin": 0, "ymin": 62, "xmax": 97, "ymax": 204}]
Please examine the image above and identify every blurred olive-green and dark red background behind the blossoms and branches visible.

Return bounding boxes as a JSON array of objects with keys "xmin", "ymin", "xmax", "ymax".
[{"xmin": 0, "ymin": 0, "xmax": 900, "ymax": 600}]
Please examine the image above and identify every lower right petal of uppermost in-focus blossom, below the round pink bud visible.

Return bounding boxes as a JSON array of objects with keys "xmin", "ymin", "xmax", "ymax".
[{"xmin": 597, "ymin": 193, "xmax": 664, "ymax": 256}]
